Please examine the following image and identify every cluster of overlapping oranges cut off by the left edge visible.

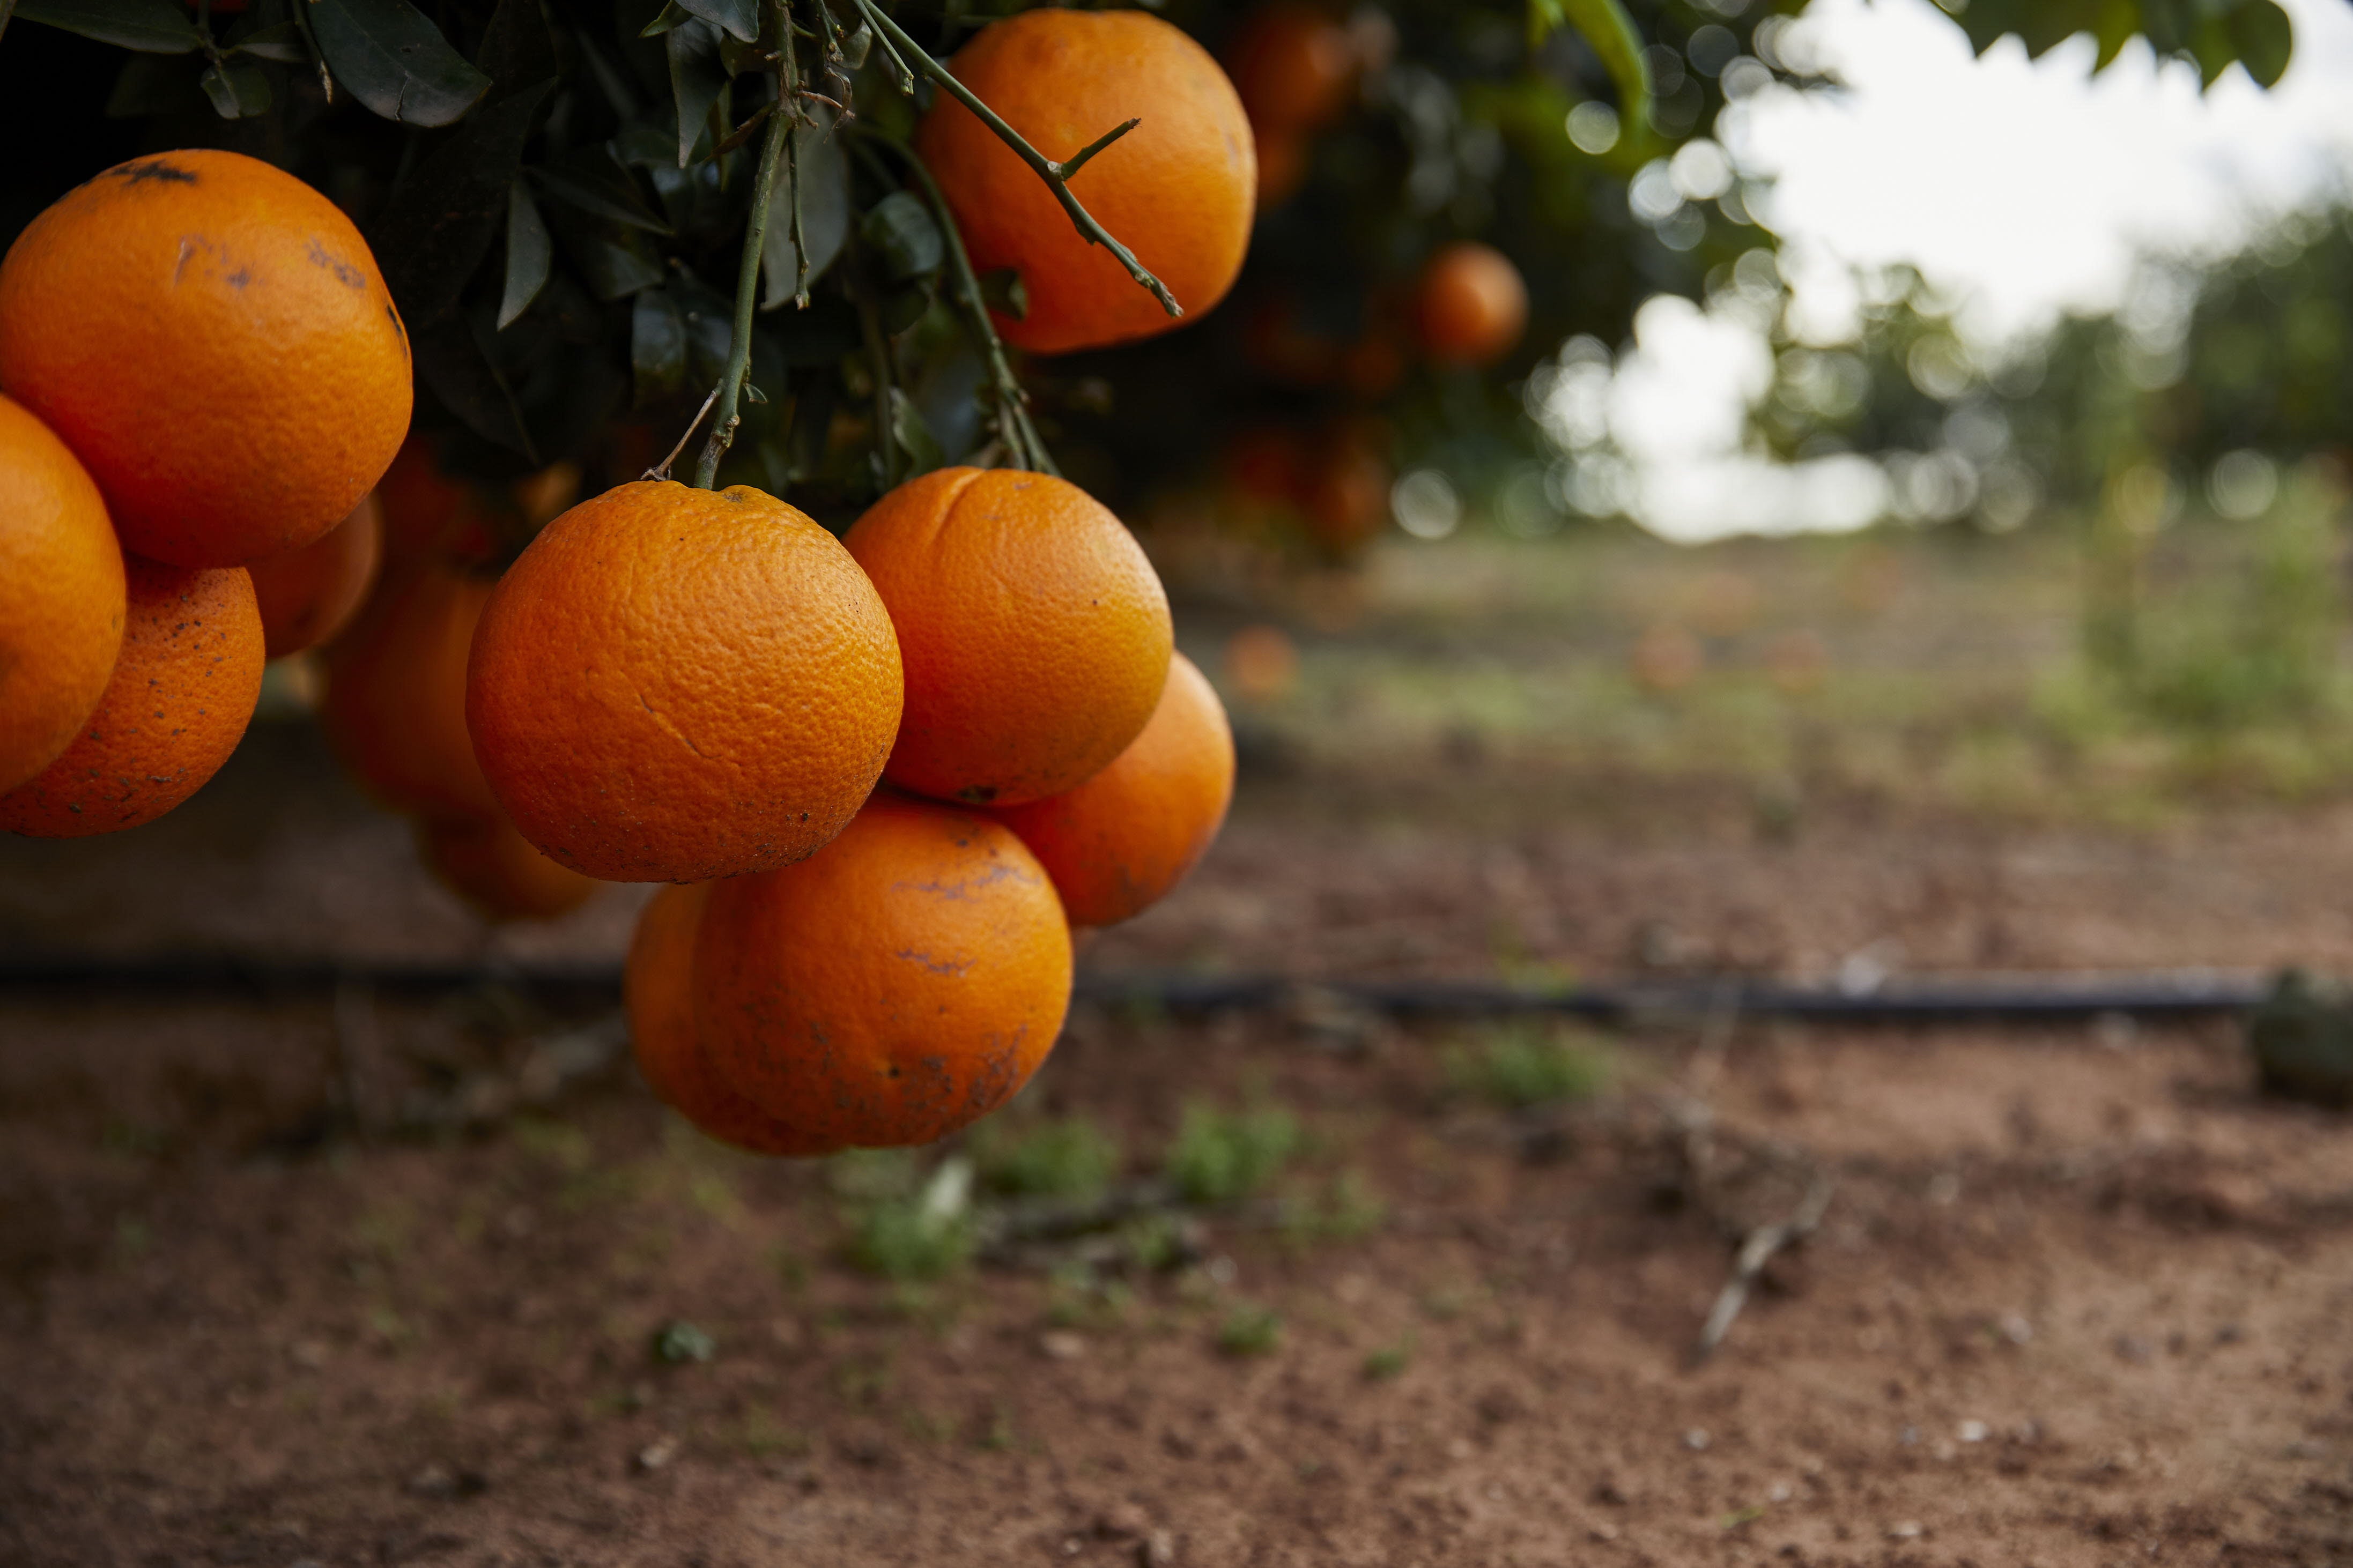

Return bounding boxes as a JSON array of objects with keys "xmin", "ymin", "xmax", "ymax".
[{"xmin": 0, "ymin": 151, "xmax": 410, "ymax": 837}]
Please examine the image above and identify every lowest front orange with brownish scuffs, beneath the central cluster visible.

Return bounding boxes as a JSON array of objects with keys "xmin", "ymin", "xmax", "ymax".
[{"xmin": 694, "ymin": 794, "xmax": 1071, "ymax": 1147}]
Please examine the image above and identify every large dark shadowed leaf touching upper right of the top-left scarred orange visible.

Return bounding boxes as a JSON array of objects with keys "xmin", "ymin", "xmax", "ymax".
[{"xmin": 369, "ymin": 84, "xmax": 548, "ymax": 327}]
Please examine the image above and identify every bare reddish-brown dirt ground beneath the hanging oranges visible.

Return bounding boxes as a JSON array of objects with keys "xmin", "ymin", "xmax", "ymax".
[{"xmin": 0, "ymin": 726, "xmax": 2353, "ymax": 1568}]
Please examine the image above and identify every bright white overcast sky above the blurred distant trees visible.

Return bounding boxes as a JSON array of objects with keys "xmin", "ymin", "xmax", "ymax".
[{"xmin": 1551, "ymin": 0, "xmax": 2353, "ymax": 538}]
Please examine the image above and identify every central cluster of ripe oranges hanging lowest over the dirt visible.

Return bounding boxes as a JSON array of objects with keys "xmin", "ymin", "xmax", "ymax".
[{"xmin": 607, "ymin": 468, "xmax": 1233, "ymax": 1154}]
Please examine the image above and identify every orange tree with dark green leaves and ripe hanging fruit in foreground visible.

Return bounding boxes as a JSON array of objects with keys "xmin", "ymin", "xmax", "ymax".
[{"xmin": 0, "ymin": 0, "xmax": 2285, "ymax": 1154}]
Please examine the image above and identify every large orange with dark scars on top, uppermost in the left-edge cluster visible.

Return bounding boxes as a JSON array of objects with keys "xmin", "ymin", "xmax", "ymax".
[{"xmin": 0, "ymin": 151, "xmax": 410, "ymax": 567}]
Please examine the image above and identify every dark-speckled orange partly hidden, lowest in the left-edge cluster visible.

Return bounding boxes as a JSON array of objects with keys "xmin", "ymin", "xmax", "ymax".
[{"xmin": 0, "ymin": 555, "xmax": 261, "ymax": 839}]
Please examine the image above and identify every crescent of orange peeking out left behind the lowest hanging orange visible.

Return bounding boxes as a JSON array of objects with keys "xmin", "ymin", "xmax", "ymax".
[{"xmin": 621, "ymin": 881, "xmax": 840, "ymax": 1154}]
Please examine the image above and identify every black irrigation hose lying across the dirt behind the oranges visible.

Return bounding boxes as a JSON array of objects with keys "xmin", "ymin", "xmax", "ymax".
[{"xmin": 0, "ymin": 954, "xmax": 2270, "ymax": 1023}]
